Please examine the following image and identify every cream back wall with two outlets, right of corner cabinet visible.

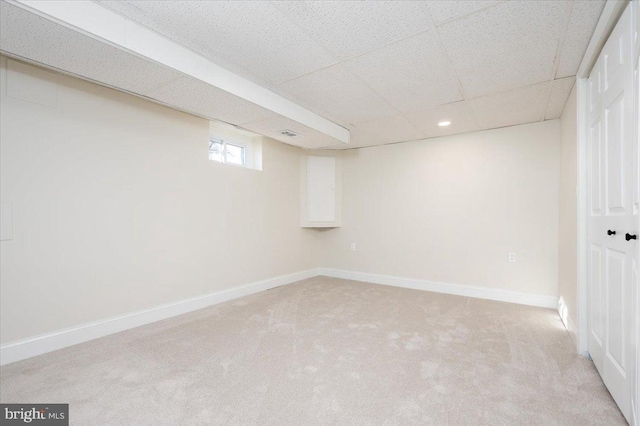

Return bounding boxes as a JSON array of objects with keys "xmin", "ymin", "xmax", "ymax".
[{"xmin": 323, "ymin": 120, "xmax": 560, "ymax": 297}]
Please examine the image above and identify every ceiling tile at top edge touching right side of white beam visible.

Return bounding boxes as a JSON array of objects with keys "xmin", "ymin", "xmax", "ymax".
[{"xmin": 100, "ymin": 1, "xmax": 336, "ymax": 84}]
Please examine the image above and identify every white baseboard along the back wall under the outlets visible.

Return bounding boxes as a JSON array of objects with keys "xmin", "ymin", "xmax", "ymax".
[{"xmin": 318, "ymin": 268, "xmax": 558, "ymax": 309}]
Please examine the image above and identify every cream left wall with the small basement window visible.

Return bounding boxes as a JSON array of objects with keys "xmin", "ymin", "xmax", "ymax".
[{"xmin": 0, "ymin": 58, "xmax": 318, "ymax": 343}]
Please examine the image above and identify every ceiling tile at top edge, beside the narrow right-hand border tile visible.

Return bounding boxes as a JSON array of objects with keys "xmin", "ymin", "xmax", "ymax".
[{"xmin": 438, "ymin": 1, "xmax": 566, "ymax": 98}]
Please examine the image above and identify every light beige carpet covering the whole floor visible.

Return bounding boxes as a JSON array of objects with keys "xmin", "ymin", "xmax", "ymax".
[{"xmin": 0, "ymin": 277, "xmax": 626, "ymax": 425}]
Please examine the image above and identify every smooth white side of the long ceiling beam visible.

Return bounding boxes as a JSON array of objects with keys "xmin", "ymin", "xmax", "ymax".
[{"xmin": 10, "ymin": 0, "xmax": 350, "ymax": 144}]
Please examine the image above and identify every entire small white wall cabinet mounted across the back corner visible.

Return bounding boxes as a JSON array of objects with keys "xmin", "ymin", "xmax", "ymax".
[{"xmin": 300, "ymin": 155, "xmax": 342, "ymax": 228}]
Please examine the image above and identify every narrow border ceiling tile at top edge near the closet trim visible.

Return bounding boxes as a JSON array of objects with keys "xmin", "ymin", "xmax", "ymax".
[{"xmin": 556, "ymin": 0, "xmax": 605, "ymax": 78}]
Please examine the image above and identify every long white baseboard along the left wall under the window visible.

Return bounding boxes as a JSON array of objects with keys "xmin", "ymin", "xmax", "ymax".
[{"xmin": 0, "ymin": 269, "xmax": 318, "ymax": 365}]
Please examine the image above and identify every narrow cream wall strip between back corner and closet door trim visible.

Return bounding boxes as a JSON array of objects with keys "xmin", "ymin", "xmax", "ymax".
[{"xmin": 558, "ymin": 86, "xmax": 578, "ymax": 338}]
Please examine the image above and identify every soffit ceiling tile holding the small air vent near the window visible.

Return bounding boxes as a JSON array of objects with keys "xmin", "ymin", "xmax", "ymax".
[{"xmin": 242, "ymin": 116, "xmax": 348, "ymax": 149}]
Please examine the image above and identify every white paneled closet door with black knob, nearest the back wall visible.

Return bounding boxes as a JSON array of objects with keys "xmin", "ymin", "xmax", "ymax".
[{"xmin": 587, "ymin": 4, "xmax": 639, "ymax": 421}]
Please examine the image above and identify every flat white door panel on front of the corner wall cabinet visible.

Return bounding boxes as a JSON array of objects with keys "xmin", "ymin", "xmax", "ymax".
[{"xmin": 307, "ymin": 155, "xmax": 336, "ymax": 222}]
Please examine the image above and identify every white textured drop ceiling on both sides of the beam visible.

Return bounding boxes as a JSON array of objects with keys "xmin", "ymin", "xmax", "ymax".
[{"xmin": 1, "ymin": 0, "xmax": 605, "ymax": 148}]
